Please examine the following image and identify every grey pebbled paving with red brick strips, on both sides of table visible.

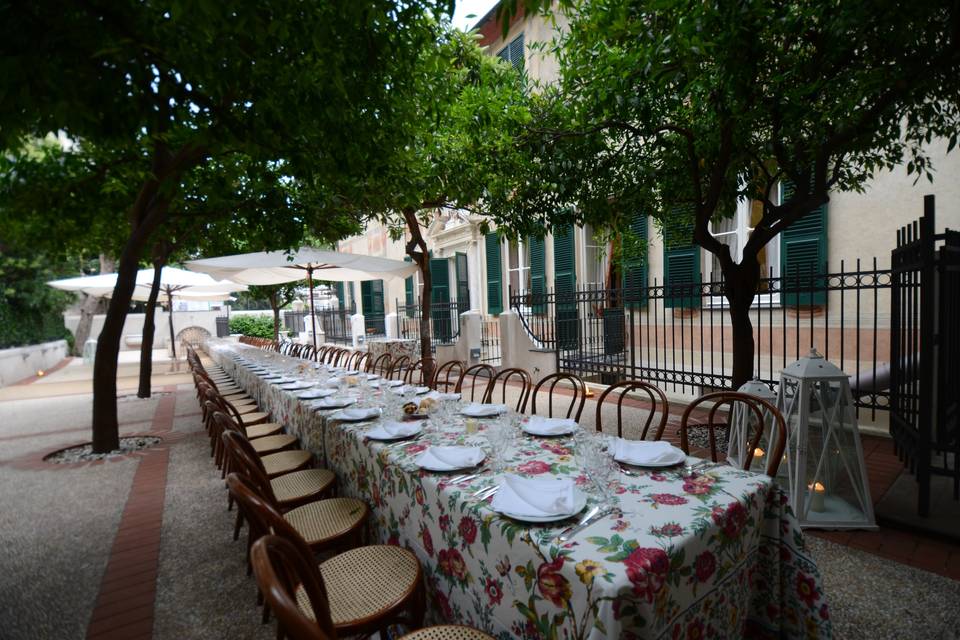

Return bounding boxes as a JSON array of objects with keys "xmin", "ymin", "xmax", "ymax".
[{"xmin": 0, "ymin": 362, "xmax": 960, "ymax": 640}]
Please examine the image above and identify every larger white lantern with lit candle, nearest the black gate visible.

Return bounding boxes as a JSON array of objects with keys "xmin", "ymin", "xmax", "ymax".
[{"xmin": 777, "ymin": 349, "xmax": 876, "ymax": 529}]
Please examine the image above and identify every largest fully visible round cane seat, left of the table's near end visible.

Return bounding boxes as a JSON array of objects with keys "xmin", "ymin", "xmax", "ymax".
[{"xmin": 297, "ymin": 545, "xmax": 420, "ymax": 635}]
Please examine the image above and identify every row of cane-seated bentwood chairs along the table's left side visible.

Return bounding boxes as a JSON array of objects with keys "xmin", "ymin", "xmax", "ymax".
[{"xmin": 187, "ymin": 349, "xmax": 489, "ymax": 640}]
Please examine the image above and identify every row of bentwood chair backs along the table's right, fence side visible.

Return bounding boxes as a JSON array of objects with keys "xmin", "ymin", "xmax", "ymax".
[{"xmin": 236, "ymin": 343, "xmax": 786, "ymax": 475}]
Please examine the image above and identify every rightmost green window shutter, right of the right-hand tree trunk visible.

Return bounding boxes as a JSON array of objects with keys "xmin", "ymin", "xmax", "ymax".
[{"xmin": 780, "ymin": 182, "xmax": 827, "ymax": 306}]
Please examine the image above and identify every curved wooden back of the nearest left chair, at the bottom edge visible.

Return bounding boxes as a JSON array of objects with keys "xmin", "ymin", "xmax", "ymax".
[{"xmin": 250, "ymin": 535, "xmax": 337, "ymax": 640}]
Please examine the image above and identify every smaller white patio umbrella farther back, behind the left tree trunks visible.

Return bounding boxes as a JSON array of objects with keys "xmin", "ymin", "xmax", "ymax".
[{"xmin": 47, "ymin": 267, "xmax": 247, "ymax": 359}]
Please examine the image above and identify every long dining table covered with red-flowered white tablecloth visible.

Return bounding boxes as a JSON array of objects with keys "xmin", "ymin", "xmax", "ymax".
[{"xmin": 206, "ymin": 339, "xmax": 832, "ymax": 640}]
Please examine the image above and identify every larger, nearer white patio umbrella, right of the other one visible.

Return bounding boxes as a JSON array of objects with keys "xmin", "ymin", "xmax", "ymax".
[{"xmin": 186, "ymin": 247, "xmax": 417, "ymax": 347}]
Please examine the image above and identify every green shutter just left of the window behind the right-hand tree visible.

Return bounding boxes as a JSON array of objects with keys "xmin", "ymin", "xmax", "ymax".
[{"xmin": 663, "ymin": 206, "xmax": 701, "ymax": 309}]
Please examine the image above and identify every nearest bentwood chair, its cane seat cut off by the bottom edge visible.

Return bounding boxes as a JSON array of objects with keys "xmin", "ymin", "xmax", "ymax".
[{"xmin": 250, "ymin": 535, "xmax": 491, "ymax": 640}]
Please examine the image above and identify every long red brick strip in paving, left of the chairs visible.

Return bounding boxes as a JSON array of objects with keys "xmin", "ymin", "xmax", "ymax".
[{"xmin": 86, "ymin": 395, "xmax": 178, "ymax": 640}]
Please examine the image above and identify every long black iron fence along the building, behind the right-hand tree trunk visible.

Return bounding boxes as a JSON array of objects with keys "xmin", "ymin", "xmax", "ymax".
[{"xmin": 510, "ymin": 258, "xmax": 891, "ymax": 419}]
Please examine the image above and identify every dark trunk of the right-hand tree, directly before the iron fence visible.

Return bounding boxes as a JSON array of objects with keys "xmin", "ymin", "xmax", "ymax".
[{"xmin": 721, "ymin": 256, "xmax": 760, "ymax": 389}]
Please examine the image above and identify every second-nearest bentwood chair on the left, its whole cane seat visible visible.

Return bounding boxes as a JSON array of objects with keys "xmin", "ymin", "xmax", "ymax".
[{"xmin": 227, "ymin": 473, "xmax": 424, "ymax": 638}]
